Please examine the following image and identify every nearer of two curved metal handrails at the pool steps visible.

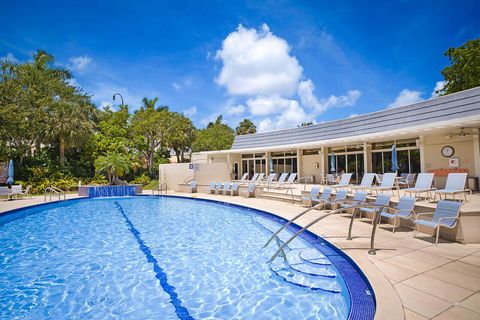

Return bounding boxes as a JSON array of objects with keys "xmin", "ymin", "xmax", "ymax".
[{"xmin": 268, "ymin": 203, "xmax": 388, "ymax": 262}]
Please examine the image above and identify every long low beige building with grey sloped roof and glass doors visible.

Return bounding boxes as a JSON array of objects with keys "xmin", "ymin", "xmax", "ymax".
[{"xmin": 192, "ymin": 87, "xmax": 480, "ymax": 186}]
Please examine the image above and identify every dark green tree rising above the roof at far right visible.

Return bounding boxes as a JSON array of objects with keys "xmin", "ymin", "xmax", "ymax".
[{"xmin": 437, "ymin": 39, "xmax": 480, "ymax": 94}]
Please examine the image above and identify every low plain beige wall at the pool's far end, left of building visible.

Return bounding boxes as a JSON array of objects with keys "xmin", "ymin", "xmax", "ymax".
[{"xmin": 159, "ymin": 162, "xmax": 230, "ymax": 190}]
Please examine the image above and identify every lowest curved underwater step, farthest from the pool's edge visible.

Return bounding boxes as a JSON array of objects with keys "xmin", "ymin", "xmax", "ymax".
[{"xmin": 270, "ymin": 258, "xmax": 342, "ymax": 293}]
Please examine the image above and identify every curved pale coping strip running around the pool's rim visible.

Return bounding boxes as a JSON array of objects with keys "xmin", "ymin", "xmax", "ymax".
[{"xmin": 0, "ymin": 193, "xmax": 405, "ymax": 320}]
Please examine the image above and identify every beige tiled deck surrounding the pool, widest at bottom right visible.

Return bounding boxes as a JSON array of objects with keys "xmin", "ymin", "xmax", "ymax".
[{"xmin": 0, "ymin": 191, "xmax": 480, "ymax": 320}]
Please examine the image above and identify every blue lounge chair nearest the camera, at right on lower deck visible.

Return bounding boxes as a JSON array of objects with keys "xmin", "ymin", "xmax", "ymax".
[{"xmin": 414, "ymin": 200, "xmax": 462, "ymax": 245}]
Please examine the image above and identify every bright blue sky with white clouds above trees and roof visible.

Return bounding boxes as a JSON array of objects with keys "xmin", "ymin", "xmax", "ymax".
[{"xmin": 0, "ymin": 0, "xmax": 480, "ymax": 131}]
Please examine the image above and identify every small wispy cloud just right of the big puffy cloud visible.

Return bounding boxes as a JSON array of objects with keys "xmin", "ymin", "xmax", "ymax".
[{"xmin": 297, "ymin": 79, "xmax": 361, "ymax": 115}]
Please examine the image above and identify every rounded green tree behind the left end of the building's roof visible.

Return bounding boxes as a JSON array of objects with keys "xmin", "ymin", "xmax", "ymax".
[{"xmin": 192, "ymin": 116, "xmax": 235, "ymax": 152}]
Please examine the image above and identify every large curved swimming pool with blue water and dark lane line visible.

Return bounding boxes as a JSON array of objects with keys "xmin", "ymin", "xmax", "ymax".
[{"xmin": 0, "ymin": 196, "xmax": 375, "ymax": 319}]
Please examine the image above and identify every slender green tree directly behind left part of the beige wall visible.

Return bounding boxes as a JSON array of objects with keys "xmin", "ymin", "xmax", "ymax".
[{"xmin": 167, "ymin": 112, "xmax": 197, "ymax": 163}]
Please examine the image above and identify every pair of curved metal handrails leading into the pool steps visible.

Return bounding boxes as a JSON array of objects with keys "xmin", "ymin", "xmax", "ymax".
[{"xmin": 265, "ymin": 202, "xmax": 387, "ymax": 262}]
